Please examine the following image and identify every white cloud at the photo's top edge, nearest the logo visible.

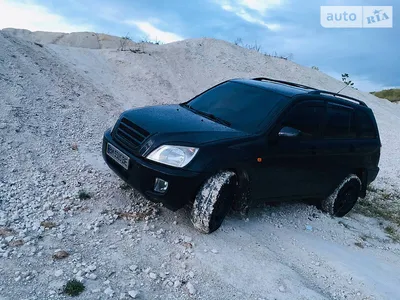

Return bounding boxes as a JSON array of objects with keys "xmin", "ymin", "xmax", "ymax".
[{"xmin": 218, "ymin": 0, "xmax": 282, "ymax": 31}]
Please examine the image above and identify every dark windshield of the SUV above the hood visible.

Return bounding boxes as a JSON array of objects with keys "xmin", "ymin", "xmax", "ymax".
[{"xmin": 183, "ymin": 81, "xmax": 290, "ymax": 133}]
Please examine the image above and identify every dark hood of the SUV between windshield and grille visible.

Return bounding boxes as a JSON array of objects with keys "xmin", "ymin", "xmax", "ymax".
[{"xmin": 121, "ymin": 105, "xmax": 249, "ymax": 144}]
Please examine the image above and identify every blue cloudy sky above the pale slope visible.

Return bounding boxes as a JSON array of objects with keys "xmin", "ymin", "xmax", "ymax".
[{"xmin": 0, "ymin": 0, "xmax": 400, "ymax": 91}]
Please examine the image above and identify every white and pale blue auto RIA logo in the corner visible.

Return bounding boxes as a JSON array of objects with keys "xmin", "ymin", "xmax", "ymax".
[{"xmin": 321, "ymin": 6, "xmax": 393, "ymax": 28}]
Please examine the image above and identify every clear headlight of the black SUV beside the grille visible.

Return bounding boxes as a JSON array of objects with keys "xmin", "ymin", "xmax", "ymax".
[{"xmin": 147, "ymin": 145, "xmax": 199, "ymax": 168}]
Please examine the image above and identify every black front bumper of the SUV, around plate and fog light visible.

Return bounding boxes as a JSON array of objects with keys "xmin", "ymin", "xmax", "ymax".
[{"xmin": 102, "ymin": 129, "xmax": 209, "ymax": 211}]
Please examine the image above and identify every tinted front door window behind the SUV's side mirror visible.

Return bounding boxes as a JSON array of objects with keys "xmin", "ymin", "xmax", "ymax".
[{"xmin": 283, "ymin": 102, "xmax": 325, "ymax": 137}]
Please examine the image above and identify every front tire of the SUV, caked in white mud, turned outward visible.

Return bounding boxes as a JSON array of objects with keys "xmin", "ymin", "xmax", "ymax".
[{"xmin": 191, "ymin": 171, "xmax": 237, "ymax": 234}]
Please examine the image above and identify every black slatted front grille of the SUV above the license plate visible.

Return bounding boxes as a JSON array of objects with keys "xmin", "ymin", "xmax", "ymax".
[{"xmin": 115, "ymin": 118, "xmax": 150, "ymax": 149}]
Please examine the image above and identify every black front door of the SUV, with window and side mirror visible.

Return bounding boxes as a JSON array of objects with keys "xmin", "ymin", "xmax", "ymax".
[{"xmin": 252, "ymin": 100, "xmax": 326, "ymax": 200}]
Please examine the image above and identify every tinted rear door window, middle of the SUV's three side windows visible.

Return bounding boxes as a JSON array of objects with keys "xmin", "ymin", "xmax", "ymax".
[{"xmin": 324, "ymin": 104, "xmax": 356, "ymax": 138}]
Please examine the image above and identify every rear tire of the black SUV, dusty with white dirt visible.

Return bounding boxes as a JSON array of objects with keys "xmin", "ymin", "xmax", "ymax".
[{"xmin": 321, "ymin": 174, "xmax": 361, "ymax": 217}]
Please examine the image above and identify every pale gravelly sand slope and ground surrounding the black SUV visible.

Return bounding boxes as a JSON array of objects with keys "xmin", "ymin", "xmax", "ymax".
[{"xmin": 0, "ymin": 30, "xmax": 400, "ymax": 299}]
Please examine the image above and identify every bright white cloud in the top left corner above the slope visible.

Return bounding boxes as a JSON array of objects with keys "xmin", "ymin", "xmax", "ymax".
[{"xmin": 0, "ymin": 0, "xmax": 93, "ymax": 33}]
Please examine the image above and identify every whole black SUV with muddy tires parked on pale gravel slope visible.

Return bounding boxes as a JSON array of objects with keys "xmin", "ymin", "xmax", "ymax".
[{"xmin": 102, "ymin": 78, "xmax": 381, "ymax": 233}]
